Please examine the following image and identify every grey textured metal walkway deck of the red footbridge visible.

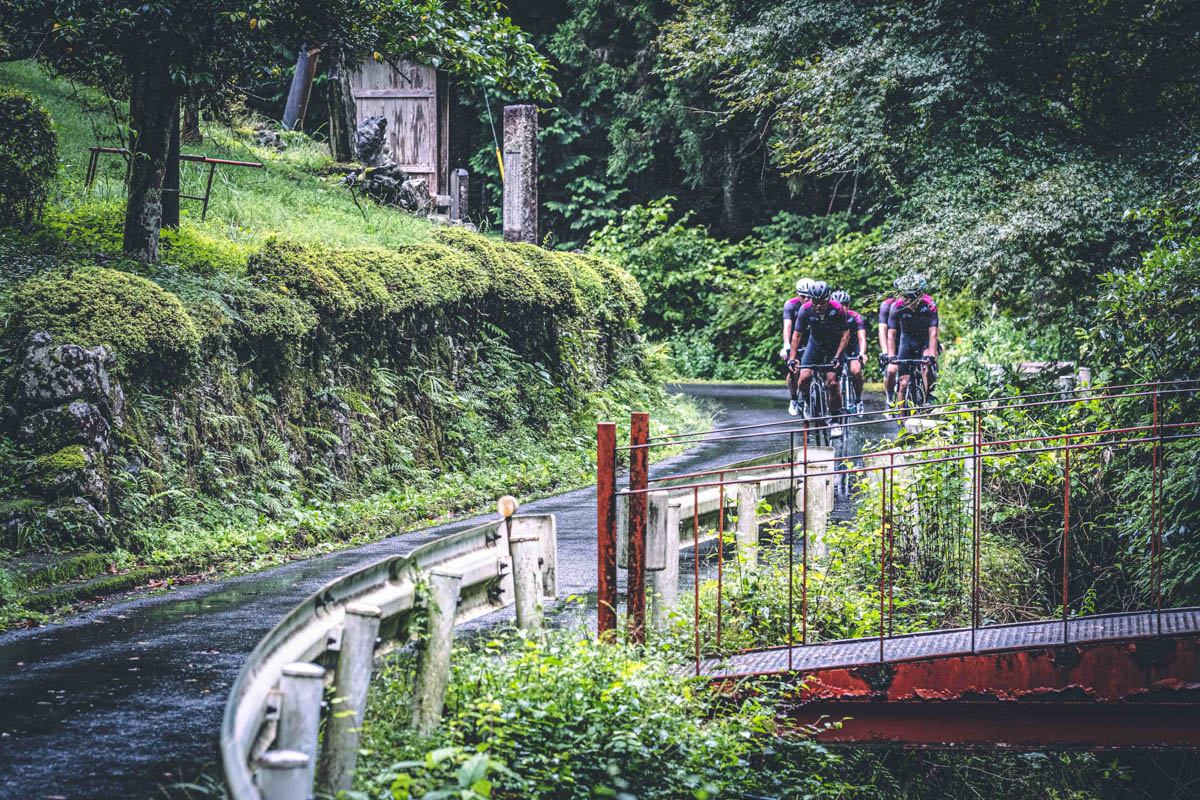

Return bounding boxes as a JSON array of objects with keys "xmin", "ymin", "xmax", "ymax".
[{"xmin": 691, "ymin": 608, "xmax": 1200, "ymax": 678}]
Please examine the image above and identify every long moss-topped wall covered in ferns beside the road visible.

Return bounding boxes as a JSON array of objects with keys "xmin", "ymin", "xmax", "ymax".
[{"xmin": 0, "ymin": 228, "xmax": 644, "ymax": 540}]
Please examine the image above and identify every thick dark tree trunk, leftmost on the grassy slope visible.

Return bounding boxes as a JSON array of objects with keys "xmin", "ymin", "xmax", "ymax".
[{"xmin": 121, "ymin": 66, "xmax": 179, "ymax": 261}]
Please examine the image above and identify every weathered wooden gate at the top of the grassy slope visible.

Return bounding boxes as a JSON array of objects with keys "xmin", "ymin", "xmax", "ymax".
[{"xmin": 350, "ymin": 61, "xmax": 450, "ymax": 196}]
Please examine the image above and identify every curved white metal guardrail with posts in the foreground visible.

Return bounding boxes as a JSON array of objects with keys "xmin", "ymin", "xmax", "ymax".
[{"xmin": 221, "ymin": 513, "xmax": 558, "ymax": 800}]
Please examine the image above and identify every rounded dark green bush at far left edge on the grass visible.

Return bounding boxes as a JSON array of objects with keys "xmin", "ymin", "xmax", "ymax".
[{"xmin": 0, "ymin": 86, "xmax": 59, "ymax": 228}]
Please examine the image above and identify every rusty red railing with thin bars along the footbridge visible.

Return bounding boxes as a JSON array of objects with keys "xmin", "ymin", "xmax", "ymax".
[{"xmin": 596, "ymin": 380, "xmax": 1200, "ymax": 674}]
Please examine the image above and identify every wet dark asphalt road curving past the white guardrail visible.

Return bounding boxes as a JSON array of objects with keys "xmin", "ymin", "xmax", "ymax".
[{"xmin": 0, "ymin": 384, "xmax": 882, "ymax": 800}]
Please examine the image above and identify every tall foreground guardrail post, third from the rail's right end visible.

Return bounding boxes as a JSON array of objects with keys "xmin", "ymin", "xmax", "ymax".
[{"xmin": 320, "ymin": 603, "xmax": 382, "ymax": 795}]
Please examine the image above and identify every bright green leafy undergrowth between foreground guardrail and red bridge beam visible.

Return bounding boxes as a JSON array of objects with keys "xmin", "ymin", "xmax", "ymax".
[{"xmin": 358, "ymin": 632, "xmax": 836, "ymax": 800}]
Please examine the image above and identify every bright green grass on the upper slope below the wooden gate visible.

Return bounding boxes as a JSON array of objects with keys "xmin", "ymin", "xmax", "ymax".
[{"xmin": 0, "ymin": 61, "xmax": 441, "ymax": 256}]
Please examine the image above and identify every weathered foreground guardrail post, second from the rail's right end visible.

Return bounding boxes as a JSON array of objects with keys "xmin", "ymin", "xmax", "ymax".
[{"xmin": 413, "ymin": 570, "xmax": 462, "ymax": 735}]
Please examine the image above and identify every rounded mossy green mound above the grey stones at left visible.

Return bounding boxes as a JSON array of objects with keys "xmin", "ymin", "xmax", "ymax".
[{"xmin": 13, "ymin": 266, "xmax": 199, "ymax": 377}]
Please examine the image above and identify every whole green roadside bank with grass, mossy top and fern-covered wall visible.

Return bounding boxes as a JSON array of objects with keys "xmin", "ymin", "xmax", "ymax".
[{"xmin": 0, "ymin": 65, "xmax": 695, "ymax": 621}]
